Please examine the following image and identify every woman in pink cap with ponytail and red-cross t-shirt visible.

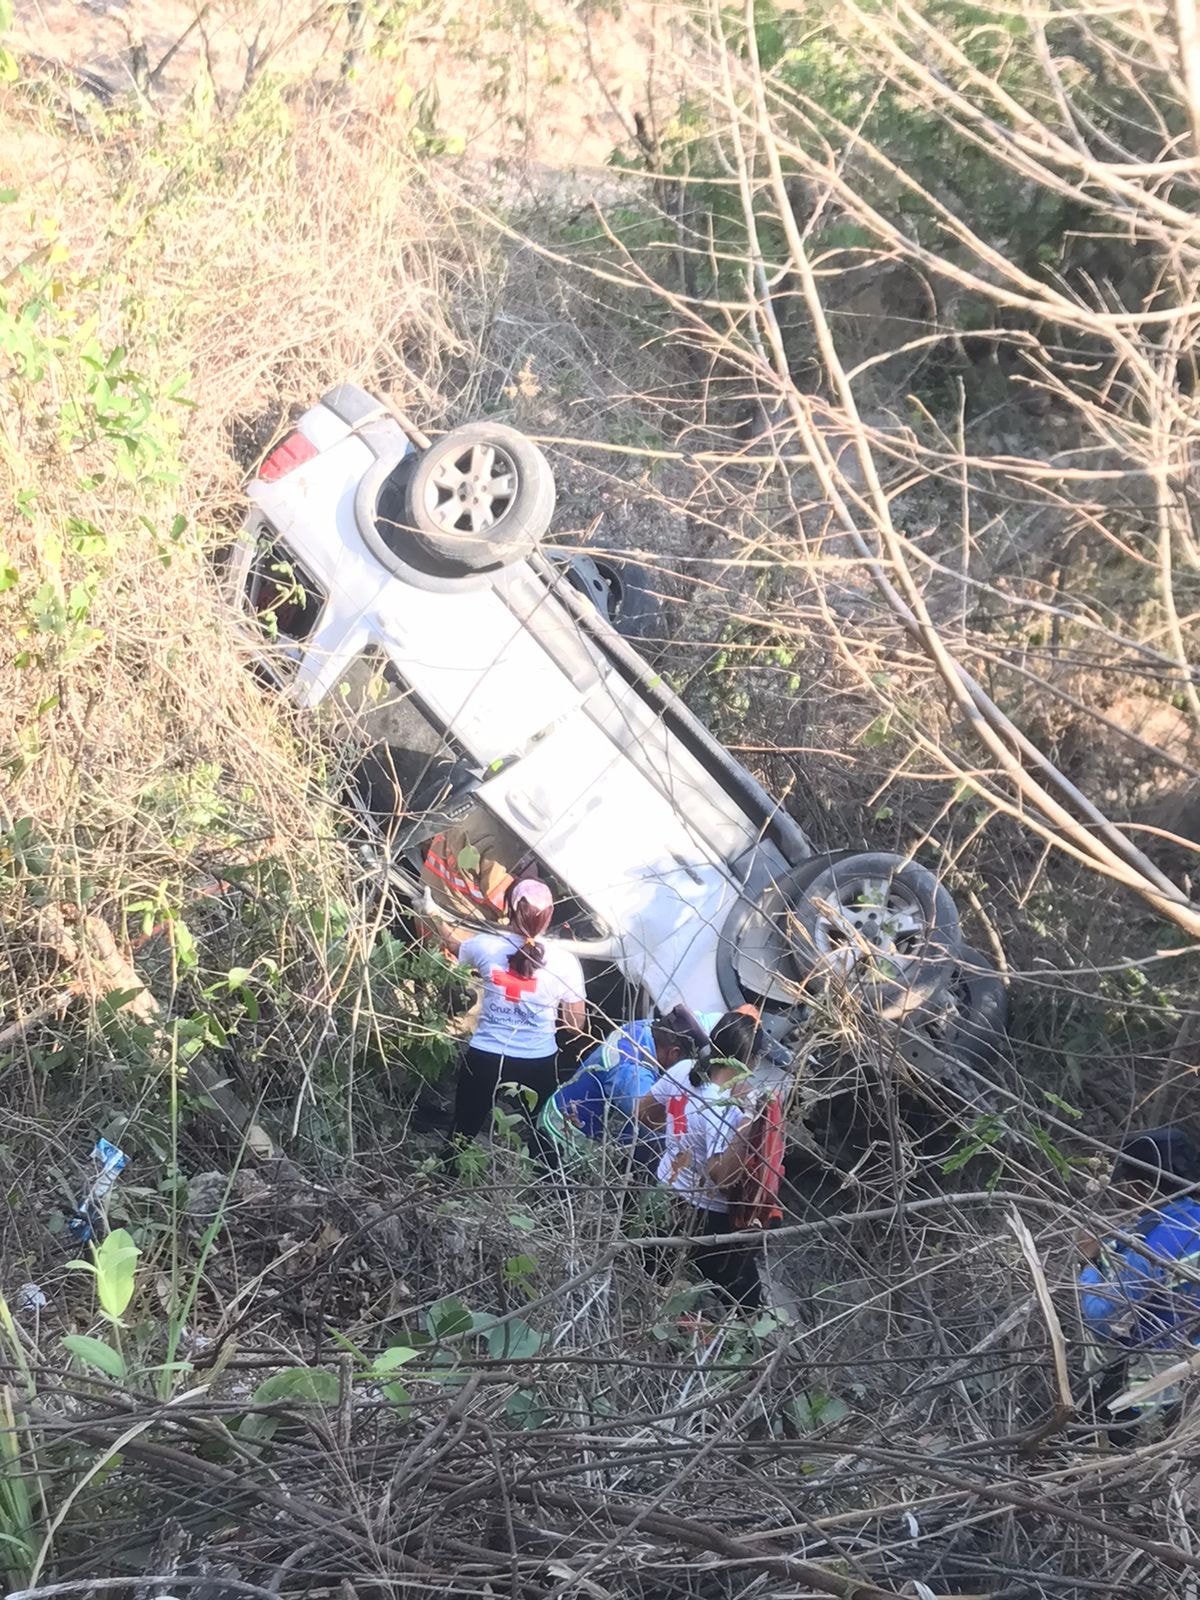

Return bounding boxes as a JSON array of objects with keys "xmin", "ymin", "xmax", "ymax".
[{"xmin": 442, "ymin": 878, "xmax": 584, "ymax": 1164}]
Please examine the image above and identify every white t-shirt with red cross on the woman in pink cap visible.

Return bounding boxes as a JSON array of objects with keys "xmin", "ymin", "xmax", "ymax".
[{"xmin": 458, "ymin": 933, "xmax": 584, "ymax": 1061}]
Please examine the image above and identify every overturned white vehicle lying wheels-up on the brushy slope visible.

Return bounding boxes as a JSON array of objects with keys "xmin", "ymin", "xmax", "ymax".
[{"xmin": 230, "ymin": 384, "xmax": 1006, "ymax": 1100}]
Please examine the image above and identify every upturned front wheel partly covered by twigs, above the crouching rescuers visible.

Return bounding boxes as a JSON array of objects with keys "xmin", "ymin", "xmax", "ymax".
[{"xmin": 784, "ymin": 853, "xmax": 960, "ymax": 1019}]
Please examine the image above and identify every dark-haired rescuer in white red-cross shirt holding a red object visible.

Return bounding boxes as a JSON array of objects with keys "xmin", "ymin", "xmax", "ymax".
[{"xmin": 637, "ymin": 1006, "xmax": 763, "ymax": 1310}]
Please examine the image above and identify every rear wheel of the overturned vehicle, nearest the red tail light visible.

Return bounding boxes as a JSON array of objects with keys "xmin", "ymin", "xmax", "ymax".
[{"xmin": 398, "ymin": 422, "xmax": 555, "ymax": 576}]
